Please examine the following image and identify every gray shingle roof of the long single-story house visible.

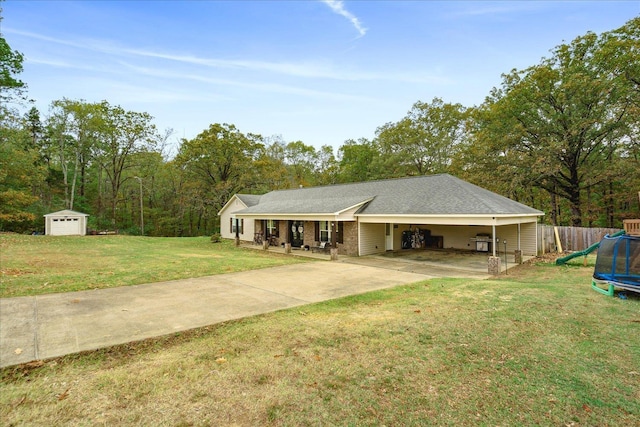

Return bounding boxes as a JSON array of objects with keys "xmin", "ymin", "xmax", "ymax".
[{"xmin": 232, "ymin": 174, "xmax": 542, "ymax": 215}]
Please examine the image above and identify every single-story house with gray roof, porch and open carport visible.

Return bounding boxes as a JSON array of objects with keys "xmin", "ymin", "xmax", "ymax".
[{"xmin": 218, "ymin": 174, "xmax": 544, "ymax": 256}]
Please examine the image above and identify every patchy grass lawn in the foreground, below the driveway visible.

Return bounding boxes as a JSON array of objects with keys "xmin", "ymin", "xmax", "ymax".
[{"xmin": 0, "ymin": 252, "xmax": 640, "ymax": 426}]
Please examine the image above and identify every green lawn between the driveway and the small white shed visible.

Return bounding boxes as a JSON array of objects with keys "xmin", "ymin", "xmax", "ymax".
[{"xmin": 0, "ymin": 234, "xmax": 305, "ymax": 298}]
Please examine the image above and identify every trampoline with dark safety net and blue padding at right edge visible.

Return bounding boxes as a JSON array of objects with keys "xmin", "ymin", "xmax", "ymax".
[{"xmin": 591, "ymin": 234, "xmax": 640, "ymax": 296}]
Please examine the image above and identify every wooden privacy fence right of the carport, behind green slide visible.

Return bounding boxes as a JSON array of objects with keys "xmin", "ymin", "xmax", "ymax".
[{"xmin": 538, "ymin": 225, "xmax": 620, "ymax": 254}]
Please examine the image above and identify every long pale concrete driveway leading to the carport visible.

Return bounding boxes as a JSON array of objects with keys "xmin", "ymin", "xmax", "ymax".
[{"xmin": 0, "ymin": 259, "xmax": 436, "ymax": 367}]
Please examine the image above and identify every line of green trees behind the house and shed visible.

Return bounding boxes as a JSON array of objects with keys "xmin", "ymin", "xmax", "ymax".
[{"xmin": 0, "ymin": 18, "xmax": 640, "ymax": 236}]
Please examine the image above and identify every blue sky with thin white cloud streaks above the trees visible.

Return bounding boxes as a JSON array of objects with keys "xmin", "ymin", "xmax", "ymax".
[{"xmin": 0, "ymin": 0, "xmax": 640, "ymax": 149}]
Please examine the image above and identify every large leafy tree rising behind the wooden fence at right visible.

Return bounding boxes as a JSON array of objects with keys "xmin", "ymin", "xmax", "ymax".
[{"xmin": 464, "ymin": 19, "xmax": 640, "ymax": 226}]
